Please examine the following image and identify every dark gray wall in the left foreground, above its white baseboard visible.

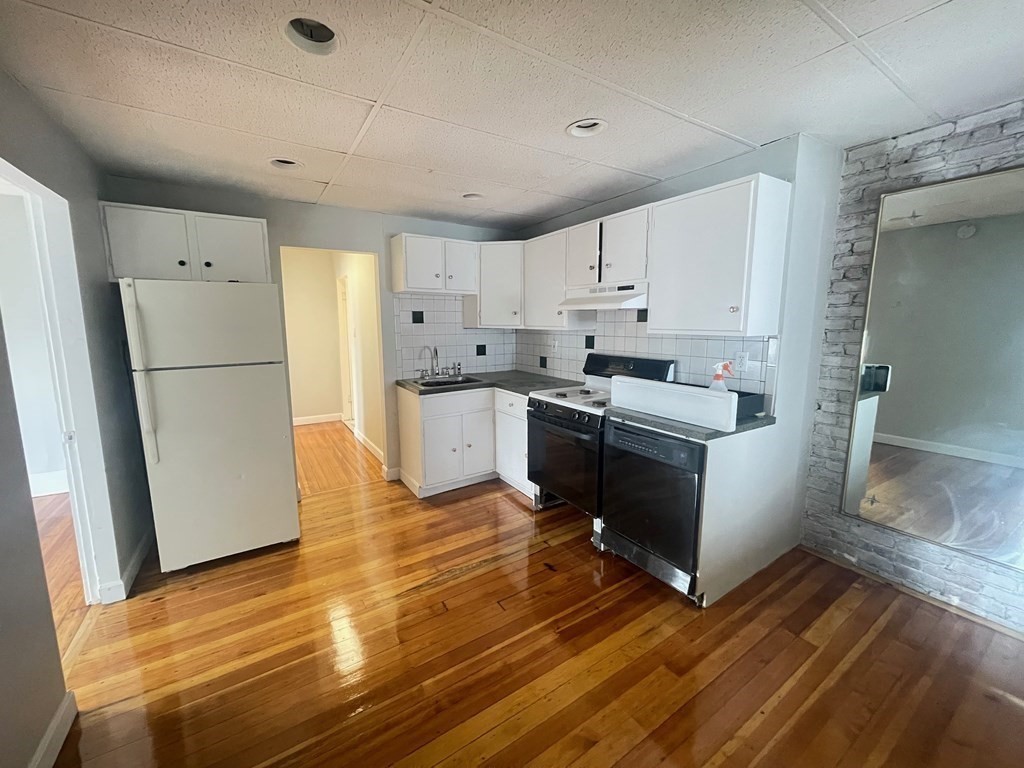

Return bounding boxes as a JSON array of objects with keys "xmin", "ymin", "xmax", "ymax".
[{"xmin": 0, "ymin": 324, "xmax": 65, "ymax": 766}]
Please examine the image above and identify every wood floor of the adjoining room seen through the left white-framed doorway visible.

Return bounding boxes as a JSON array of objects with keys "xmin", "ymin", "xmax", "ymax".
[{"xmin": 32, "ymin": 494, "xmax": 89, "ymax": 662}]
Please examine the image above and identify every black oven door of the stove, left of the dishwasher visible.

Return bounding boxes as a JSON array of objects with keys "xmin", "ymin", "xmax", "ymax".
[{"xmin": 526, "ymin": 411, "xmax": 603, "ymax": 517}]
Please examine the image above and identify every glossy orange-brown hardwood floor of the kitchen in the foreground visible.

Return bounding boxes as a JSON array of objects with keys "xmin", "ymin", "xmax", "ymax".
[{"xmin": 51, "ymin": 448, "xmax": 1024, "ymax": 768}]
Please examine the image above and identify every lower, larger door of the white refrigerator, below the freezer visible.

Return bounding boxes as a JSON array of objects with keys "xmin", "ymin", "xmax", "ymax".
[{"xmin": 134, "ymin": 364, "xmax": 299, "ymax": 571}]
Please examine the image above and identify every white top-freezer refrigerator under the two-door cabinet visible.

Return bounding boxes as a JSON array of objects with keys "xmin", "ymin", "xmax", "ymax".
[{"xmin": 119, "ymin": 278, "xmax": 299, "ymax": 571}]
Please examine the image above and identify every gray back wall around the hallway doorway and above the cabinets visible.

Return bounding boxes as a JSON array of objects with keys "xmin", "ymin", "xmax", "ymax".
[{"xmin": 103, "ymin": 176, "xmax": 508, "ymax": 475}]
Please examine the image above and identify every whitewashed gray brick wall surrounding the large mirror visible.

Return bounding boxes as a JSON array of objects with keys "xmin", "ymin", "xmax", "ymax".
[{"xmin": 804, "ymin": 101, "xmax": 1024, "ymax": 631}]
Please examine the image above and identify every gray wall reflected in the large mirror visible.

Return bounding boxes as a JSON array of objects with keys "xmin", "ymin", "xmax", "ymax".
[{"xmin": 865, "ymin": 215, "xmax": 1024, "ymax": 457}]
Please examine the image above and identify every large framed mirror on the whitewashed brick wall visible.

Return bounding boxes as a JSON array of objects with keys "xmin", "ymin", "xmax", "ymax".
[{"xmin": 844, "ymin": 169, "xmax": 1024, "ymax": 568}]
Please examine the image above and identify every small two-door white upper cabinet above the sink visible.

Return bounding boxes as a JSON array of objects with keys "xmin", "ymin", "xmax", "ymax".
[{"xmin": 391, "ymin": 234, "xmax": 478, "ymax": 294}]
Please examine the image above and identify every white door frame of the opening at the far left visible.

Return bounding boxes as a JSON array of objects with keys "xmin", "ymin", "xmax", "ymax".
[{"xmin": 0, "ymin": 158, "xmax": 101, "ymax": 605}]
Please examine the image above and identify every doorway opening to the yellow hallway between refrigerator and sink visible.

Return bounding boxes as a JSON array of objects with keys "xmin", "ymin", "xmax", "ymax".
[{"xmin": 281, "ymin": 248, "xmax": 386, "ymax": 497}]
